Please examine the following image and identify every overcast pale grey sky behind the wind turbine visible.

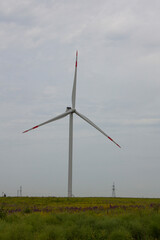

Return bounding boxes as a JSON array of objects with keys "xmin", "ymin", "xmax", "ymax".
[{"xmin": 0, "ymin": 0, "xmax": 160, "ymax": 197}]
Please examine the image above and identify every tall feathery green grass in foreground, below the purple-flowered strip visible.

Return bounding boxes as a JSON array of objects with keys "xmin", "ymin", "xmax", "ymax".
[{"xmin": 0, "ymin": 213, "xmax": 160, "ymax": 240}]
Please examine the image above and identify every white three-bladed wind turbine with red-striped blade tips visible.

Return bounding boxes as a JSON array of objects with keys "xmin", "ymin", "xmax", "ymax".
[{"xmin": 23, "ymin": 51, "xmax": 120, "ymax": 197}]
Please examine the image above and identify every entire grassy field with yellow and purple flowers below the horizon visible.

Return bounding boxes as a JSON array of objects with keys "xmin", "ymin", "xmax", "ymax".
[{"xmin": 0, "ymin": 197, "xmax": 160, "ymax": 240}]
